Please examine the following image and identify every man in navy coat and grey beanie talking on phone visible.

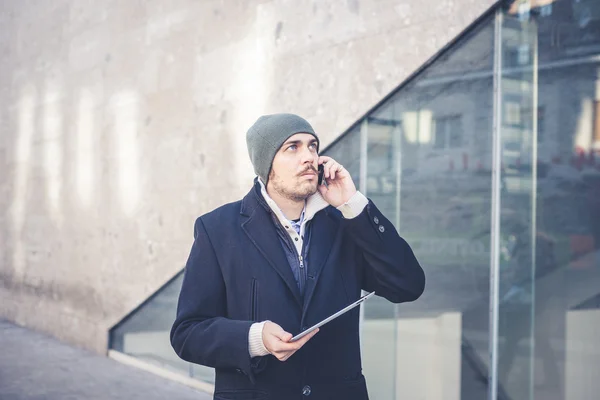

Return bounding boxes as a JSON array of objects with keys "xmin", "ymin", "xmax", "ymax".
[{"xmin": 171, "ymin": 114, "xmax": 425, "ymax": 400}]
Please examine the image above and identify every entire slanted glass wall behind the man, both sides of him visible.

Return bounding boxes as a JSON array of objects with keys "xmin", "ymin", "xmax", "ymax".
[{"xmin": 111, "ymin": 0, "xmax": 600, "ymax": 400}]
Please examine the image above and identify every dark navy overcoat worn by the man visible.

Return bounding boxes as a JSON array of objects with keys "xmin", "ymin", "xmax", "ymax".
[{"xmin": 171, "ymin": 183, "xmax": 425, "ymax": 400}]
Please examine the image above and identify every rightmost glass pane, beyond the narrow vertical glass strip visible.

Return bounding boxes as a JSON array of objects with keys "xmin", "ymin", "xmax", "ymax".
[{"xmin": 506, "ymin": 0, "xmax": 600, "ymax": 400}]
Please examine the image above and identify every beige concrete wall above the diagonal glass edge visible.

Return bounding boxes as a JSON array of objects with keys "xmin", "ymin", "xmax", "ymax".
[{"xmin": 0, "ymin": 0, "xmax": 493, "ymax": 351}]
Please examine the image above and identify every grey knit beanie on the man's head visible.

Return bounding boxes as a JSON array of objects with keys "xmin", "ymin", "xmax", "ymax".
[{"xmin": 246, "ymin": 114, "xmax": 319, "ymax": 185}]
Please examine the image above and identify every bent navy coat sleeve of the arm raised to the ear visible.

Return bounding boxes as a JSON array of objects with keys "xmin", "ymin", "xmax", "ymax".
[{"xmin": 342, "ymin": 201, "xmax": 425, "ymax": 303}]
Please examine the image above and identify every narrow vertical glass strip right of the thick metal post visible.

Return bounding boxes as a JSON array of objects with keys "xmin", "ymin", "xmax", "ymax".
[{"xmin": 497, "ymin": 7, "xmax": 543, "ymax": 399}]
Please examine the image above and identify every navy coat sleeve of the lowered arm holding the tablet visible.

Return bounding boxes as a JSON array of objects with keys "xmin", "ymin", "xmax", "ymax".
[{"xmin": 171, "ymin": 218, "xmax": 257, "ymax": 380}]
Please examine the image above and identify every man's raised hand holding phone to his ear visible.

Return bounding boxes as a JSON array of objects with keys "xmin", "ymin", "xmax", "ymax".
[{"xmin": 318, "ymin": 156, "xmax": 356, "ymax": 207}]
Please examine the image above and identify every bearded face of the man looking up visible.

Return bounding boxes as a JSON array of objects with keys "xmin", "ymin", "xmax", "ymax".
[{"xmin": 267, "ymin": 133, "xmax": 319, "ymax": 201}]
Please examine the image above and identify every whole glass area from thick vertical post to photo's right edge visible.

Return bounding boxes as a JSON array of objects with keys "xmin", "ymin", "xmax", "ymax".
[{"xmin": 499, "ymin": 0, "xmax": 600, "ymax": 400}]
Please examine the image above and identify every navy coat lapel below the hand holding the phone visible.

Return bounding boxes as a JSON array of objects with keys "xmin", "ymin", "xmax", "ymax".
[{"xmin": 302, "ymin": 211, "xmax": 339, "ymax": 319}]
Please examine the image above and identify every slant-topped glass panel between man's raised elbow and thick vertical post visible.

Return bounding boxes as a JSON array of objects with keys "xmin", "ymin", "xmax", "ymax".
[{"xmin": 326, "ymin": 15, "xmax": 494, "ymax": 400}]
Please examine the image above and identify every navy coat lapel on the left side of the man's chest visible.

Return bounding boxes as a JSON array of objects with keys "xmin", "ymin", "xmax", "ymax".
[{"xmin": 241, "ymin": 189, "xmax": 302, "ymax": 307}]
